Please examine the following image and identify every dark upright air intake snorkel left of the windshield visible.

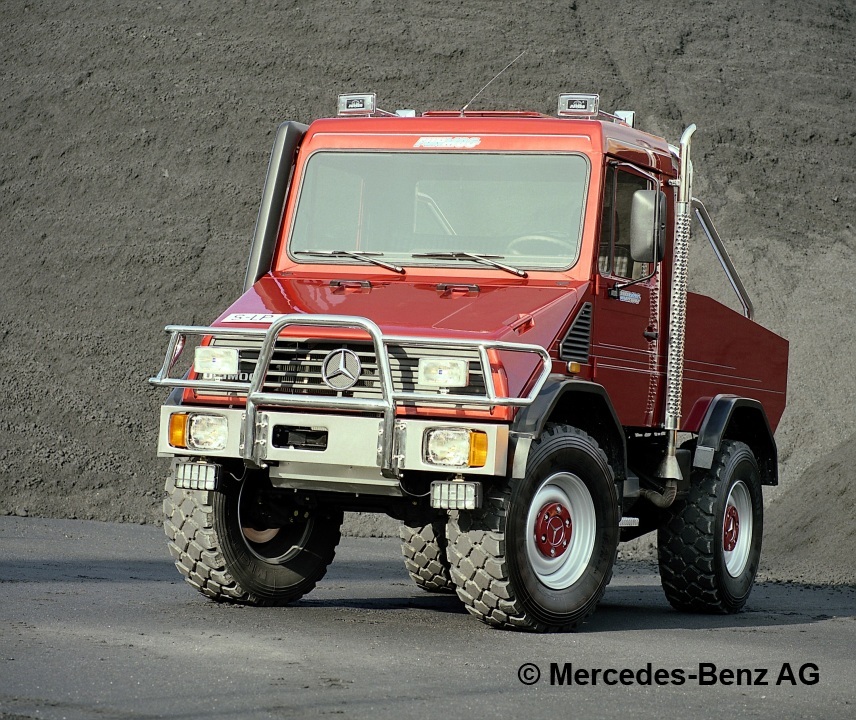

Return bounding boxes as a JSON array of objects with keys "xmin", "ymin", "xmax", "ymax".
[{"xmin": 244, "ymin": 121, "xmax": 308, "ymax": 292}]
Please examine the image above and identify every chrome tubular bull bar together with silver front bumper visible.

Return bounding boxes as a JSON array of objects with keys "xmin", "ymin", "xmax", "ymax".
[{"xmin": 149, "ymin": 315, "xmax": 551, "ymax": 494}]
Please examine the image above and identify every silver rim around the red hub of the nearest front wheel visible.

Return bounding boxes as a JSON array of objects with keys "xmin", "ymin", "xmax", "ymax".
[{"xmin": 526, "ymin": 472, "xmax": 597, "ymax": 590}]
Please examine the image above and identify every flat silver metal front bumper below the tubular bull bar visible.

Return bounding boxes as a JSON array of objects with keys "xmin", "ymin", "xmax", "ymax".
[{"xmin": 158, "ymin": 405, "xmax": 509, "ymax": 496}]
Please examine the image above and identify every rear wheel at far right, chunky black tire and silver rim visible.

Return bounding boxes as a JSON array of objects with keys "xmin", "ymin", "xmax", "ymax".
[{"xmin": 657, "ymin": 440, "xmax": 764, "ymax": 613}]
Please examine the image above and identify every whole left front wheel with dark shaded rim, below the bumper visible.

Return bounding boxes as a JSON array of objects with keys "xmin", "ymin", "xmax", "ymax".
[{"xmin": 163, "ymin": 475, "xmax": 343, "ymax": 605}]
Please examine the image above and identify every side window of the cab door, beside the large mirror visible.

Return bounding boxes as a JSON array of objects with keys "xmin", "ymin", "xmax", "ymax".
[{"xmin": 598, "ymin": 165, "xmax": 651, "ymax": 280}]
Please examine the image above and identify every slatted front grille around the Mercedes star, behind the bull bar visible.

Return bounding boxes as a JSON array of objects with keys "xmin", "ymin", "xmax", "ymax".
[{"xmin": 205, "ymin": 338, "xmax": 486, "ymax": 398}]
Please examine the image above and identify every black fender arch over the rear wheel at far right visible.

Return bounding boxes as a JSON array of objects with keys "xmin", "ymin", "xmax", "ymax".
[{"xmin": 685, "ymin": 395, "xmax": 779, "ymax": 485}]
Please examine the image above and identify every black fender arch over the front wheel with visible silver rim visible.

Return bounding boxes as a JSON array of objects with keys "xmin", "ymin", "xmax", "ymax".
[{"xmin": 511, "ymin": 375, "xmax": 627, "ymax": 484}]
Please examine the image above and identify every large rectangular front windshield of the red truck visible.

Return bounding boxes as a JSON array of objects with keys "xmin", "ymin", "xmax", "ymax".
[{"xmin": 289, "ymin": 151, "xmax": 589, "ymax": 269}]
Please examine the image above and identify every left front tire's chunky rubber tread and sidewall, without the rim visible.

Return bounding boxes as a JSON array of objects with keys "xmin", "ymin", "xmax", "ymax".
[{"xmin": 163, "ymin": 478, "xmax": 343, "ymax": 605}]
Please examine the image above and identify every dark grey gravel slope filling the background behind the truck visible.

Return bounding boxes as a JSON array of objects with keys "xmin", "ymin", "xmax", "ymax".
[{"xmin": 0, "ymin": 0, "xmax": 856, "ymax": 582}]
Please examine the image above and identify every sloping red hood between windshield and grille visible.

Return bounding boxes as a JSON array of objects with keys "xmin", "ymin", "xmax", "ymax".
[{"xmin": 215, "ymin": 275, "xmax": 584, "ymax": 348}]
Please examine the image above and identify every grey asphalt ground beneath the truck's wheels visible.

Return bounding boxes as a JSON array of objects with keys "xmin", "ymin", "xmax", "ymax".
[{"xmin": 0, "ymin": 517, "xmax": 856, "ymax": 720}]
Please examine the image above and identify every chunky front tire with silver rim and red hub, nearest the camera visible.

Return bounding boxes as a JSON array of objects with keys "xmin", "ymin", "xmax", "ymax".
[{"xmin": 447, "ymin": 424, "xmax": 619, "ymax": 632}]
